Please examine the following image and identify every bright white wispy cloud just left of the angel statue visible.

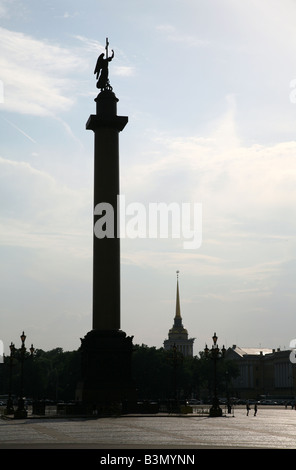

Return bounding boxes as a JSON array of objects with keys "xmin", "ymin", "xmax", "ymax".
[{"xmin": 0, "ymin": 28, "xmax": 87, "ymax": 116}]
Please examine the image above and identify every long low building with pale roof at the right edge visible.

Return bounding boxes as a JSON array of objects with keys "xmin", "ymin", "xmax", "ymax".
[{"xmin": 226, "ymin": 345, "xmax": 296, "ymax": 399}]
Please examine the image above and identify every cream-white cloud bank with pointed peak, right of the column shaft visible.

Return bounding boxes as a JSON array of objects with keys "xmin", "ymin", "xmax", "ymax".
[{"xmin": 122, "ymin": 100, "xmax": 296, "ymax": 220}]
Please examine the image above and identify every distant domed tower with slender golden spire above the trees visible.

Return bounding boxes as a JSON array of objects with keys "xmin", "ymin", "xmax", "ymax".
[{"xmin": 163, "ymin": 271, "xmax": 195, "ymax": 357}]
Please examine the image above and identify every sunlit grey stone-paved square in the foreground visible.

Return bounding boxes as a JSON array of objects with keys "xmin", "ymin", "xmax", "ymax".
[{"xmin": 0, "ymin": 407, "xmax": 296, "ymax": 449}]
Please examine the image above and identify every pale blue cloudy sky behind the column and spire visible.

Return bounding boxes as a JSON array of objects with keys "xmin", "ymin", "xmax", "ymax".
[{"xmin": 0, "ymin": 0, "xmax": 296, "ymax": 355}]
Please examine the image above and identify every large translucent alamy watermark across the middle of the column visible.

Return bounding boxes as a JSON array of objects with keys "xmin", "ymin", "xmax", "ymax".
[{"xmin": 94, "ymin": 195, "xmax": 202, "ymax": 250}]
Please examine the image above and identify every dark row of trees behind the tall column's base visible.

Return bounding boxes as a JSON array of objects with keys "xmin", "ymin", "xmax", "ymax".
[{"xmin": 0, "ymin": 344, "xmax": 238, "ymax": 402}]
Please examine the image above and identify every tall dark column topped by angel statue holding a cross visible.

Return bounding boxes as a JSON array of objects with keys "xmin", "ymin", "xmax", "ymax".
[{"xmin": 76, "ymin": 39, "xmax": 134, "ymax": 408}]
